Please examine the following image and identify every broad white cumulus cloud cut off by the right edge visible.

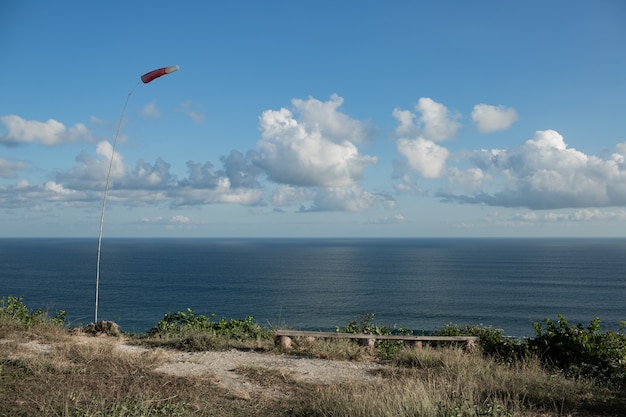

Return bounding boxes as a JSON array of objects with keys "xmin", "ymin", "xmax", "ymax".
[{"xmin": 447, "ymin": 130, "xmax": 626, "ymax": 209}]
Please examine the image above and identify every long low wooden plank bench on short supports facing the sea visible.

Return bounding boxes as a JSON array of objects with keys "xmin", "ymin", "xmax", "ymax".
[{"xmin": 274, "ymin": 330, "xmax": 479, "ymax": 350}]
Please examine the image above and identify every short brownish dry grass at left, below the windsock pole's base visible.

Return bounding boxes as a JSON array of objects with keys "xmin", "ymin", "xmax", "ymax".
[{"xmin": 0, "ymin": 318, "xmax": 288, "ymax": 417}]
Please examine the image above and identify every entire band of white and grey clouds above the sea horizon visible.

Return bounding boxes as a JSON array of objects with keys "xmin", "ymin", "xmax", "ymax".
[{"xmin": 0, "ymin": 94, "xmax": 626, "ymax": 221}]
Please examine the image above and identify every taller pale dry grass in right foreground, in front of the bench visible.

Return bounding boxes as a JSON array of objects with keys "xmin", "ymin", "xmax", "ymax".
[{"xmin": 290, "ymin": 349, "xmax": 624, "ymax": 417}]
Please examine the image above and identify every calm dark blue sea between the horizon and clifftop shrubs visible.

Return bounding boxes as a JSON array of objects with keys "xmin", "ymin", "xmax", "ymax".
[{"xmin": 0, "ymin": 238, "xmax": 626, "ymax": 336}]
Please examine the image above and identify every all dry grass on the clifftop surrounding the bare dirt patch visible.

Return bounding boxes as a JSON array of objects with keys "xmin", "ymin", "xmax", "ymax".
[{"xmin": 0, "ymin": 300, "xmax": 626, "ymax": 417}]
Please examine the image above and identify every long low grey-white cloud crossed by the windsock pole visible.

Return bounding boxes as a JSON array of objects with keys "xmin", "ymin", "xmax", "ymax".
[{"xmin": 42, "ymin": 141, "xmax": 263, "ymax": 210}]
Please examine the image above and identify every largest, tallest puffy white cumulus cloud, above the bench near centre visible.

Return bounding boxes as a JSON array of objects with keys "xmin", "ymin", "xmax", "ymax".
[{"xmin": 255, "ymin": 96, "xmax": 377, "ymax": 187}]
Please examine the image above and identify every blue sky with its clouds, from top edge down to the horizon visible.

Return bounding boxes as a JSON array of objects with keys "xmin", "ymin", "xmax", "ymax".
[{"xmin": 0, "ymin": 0, "xmax": 626, "ymax": 237}]
